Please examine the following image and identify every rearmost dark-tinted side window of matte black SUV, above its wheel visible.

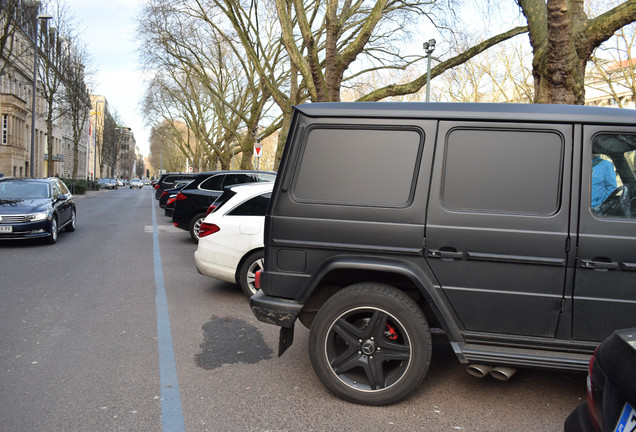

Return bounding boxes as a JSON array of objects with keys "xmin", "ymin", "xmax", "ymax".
[{"xmin": 293, "ymin": 127, "xmax": 424, "ymax": 207}]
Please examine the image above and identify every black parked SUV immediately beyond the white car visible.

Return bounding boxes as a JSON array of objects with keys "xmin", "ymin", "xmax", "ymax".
[{"xmin": 172, "ymin": 171, "xmax": 276, "ymax": 242}]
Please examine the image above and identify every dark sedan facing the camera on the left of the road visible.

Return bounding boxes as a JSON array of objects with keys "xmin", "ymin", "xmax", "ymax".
[{"xmin": 0, "ymin": 177, "xmax": 77, "ymax": 243}]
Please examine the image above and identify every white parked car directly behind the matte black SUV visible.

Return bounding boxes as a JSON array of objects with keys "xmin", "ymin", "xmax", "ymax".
[{"xmin": 194, "ymin": 183, "xmax": 274, "ymax": 297}]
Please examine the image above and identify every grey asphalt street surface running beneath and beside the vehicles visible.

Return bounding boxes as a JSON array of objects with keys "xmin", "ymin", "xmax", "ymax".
[{"xmin": 0, "ymin": 188, "xmax": 585, "ymax": 432}]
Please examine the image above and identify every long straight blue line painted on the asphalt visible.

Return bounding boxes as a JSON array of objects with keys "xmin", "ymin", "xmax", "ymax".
[{"xmin": 150, "ymin": 195, "xmax": 186, "ymax": 432}]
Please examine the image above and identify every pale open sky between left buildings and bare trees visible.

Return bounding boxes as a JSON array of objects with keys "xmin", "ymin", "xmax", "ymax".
[{"xmin": 67, "ymin": 0, "xmax": 150, "ymax": 156}]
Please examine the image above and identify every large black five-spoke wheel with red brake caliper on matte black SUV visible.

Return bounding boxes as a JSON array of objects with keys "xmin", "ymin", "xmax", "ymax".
[{"xmin": 309, "ymin": 283, "xmax": 432, "ymax": 405}]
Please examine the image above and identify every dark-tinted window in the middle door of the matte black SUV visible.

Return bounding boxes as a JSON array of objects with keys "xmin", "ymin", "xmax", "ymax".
[{"xmin": 442, "ymin": 128, "xmax": 564, "ymax": 216}]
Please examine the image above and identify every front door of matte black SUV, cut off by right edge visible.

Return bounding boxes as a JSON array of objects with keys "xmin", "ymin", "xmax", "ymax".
[{"xmin": 572, "ymin": 126, "xmax": 636, "ymax": 341}]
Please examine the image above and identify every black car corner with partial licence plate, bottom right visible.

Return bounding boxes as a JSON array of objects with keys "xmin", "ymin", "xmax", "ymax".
[{"xmin": 565, "ymin": 328, "xmax": 636, "ymax": 432}]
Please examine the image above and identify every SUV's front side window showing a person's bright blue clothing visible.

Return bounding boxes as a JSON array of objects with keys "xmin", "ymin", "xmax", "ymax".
[{"xmin": 590, "ymin": 133, "xmax": 636, "ymax": 218}]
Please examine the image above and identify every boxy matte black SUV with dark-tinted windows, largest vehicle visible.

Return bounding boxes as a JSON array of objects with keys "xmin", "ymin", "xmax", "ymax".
[{"xmin": 250, "ymin": 103, "xmax": 636, "ymax": 405}]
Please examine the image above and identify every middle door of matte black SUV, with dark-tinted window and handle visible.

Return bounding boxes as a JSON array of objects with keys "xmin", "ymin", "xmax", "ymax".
[{"xmin": 426, "ymin": 122, "xmax": 572, "ymax": 337}]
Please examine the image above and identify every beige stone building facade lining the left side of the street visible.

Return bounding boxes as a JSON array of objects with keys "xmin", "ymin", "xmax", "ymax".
[{"xmin": 0, "ymin": 2, "xmax": 89, "ymax": 178}]
